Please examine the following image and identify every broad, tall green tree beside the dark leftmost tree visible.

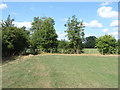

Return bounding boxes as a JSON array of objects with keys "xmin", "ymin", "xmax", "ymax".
[{"xmin": 30, "ymin": 17, "xmax": 58, "ymax": 52}]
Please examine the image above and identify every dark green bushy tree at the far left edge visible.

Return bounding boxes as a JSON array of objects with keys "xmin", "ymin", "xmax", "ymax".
[{"xmin": 0, "ymin": 15, "xmax": 29, "ymax": 56}]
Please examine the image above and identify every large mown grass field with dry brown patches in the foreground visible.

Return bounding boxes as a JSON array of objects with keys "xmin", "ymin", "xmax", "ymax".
[{"xmin": 2, "ymin": 55, "xmax": 118, "ymax": 88}]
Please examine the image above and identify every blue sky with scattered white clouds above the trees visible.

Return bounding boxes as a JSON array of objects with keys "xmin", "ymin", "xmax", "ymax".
[{"xmin": 0, "ymin": 2, "xmax": 118, "ymax": 40}]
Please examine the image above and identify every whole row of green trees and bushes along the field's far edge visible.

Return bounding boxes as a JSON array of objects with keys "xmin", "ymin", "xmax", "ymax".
[{"xmin": 0, "ymin": 15, "xmax": 120, "ymax": 56}]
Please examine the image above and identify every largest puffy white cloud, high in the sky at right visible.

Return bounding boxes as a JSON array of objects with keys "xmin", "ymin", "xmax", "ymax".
[{"xmin": 97, "ymin": 6, "xmax": 118, "ymax": 18}]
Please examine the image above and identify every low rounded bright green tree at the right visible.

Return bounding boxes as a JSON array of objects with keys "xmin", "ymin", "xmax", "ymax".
[{"xmin": 96, "ymin": 35, "xmax": 117, "ymax": 54}]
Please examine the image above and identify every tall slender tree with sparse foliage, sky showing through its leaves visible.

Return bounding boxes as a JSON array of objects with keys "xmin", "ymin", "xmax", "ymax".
[{"xmin": 65, "ymin": 15, "xmax": 85, "ymax": 53}]
